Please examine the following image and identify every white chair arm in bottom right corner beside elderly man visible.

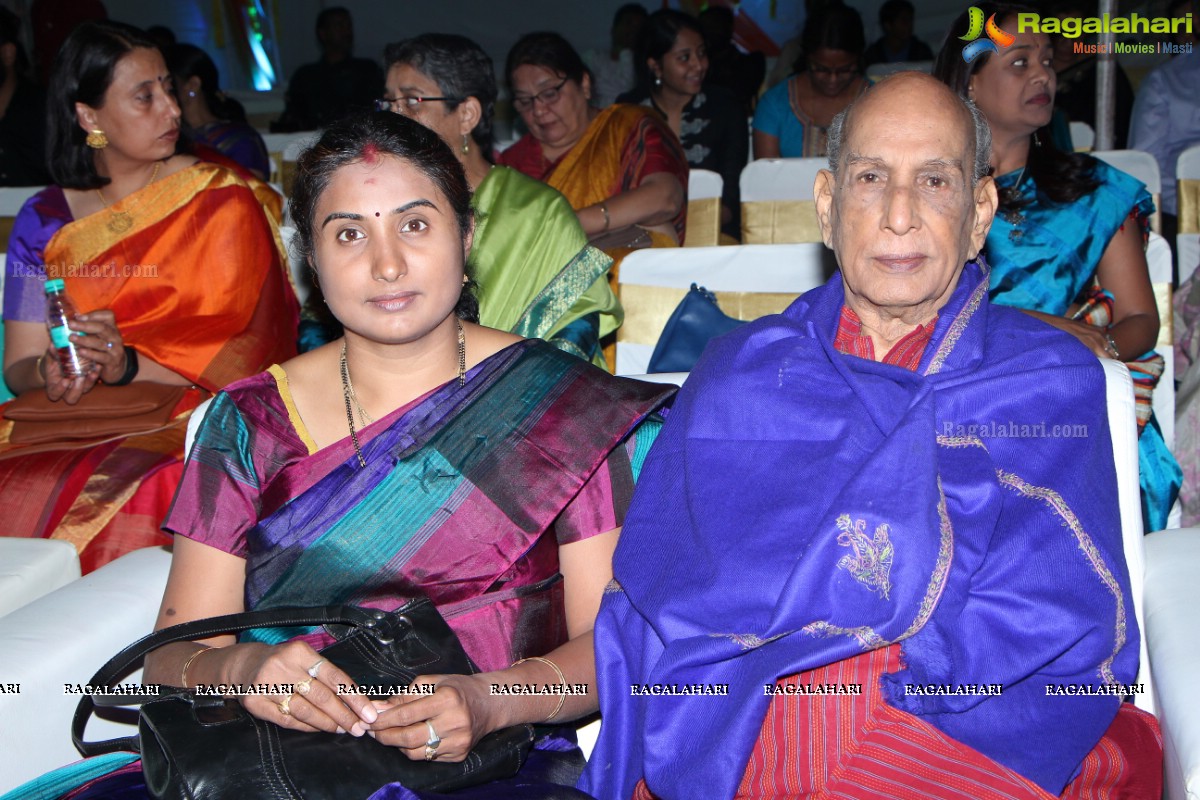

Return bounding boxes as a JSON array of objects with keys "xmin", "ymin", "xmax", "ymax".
[{"xmin": 1142, "ymin": 528, "xmax": 1200, "ymax": 800}]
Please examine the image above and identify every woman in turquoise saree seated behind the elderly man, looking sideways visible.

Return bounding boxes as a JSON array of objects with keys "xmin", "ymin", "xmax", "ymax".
[{"xmin": 934, "ymin": 4, "xmax": 1181, "ymax": 530}]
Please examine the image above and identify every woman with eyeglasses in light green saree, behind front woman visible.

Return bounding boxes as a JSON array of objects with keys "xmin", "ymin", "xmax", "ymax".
[{"xmin": 367, "ymin": 34, "xmax": 622, "ymax": 366}]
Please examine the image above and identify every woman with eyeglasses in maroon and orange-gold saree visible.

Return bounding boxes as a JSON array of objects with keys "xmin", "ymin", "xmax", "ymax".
[{"xmin": 500, "ymin": 31, "xmax": 688, "ymax": 262}]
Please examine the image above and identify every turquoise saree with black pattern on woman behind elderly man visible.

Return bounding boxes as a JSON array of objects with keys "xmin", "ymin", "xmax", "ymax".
[{"xmin": 985, "ymin": 158, "xmax": 1182, "ymax": 531}]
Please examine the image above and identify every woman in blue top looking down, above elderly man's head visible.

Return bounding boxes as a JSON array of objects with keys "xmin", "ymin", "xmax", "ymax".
[{"xmin": 754, "ymin": 4, "xmax": 871, "ymax": 158}]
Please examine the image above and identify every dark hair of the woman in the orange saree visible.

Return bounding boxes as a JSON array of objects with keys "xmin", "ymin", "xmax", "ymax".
[{"xmin": 46, "ymin": 22, "xmax": 157, "ymax": 190}]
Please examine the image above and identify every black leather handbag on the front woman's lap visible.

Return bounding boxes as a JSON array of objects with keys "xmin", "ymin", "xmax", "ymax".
[{"xmin": 71, "ymin": 597, "xmax": 534, "ymax": 800}]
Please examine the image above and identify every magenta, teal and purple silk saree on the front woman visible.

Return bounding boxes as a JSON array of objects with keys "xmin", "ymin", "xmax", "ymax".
[{"xmin": 28, "ymin": 339, "xmax": 674, "ymax": 800}]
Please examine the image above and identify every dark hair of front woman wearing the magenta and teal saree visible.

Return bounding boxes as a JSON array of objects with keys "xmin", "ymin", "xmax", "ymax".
[{"xmin": 288, "ymin": 112, "xmax": 479, "ymax": 323}]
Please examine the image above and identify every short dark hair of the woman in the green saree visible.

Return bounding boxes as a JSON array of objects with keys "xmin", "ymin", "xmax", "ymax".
[{"xmin": 383, "ymin": 34, "xmax": 497, "ymax": 161}]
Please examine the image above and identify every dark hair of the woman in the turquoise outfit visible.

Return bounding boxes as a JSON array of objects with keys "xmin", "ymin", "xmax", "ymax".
[{"xmin": 934, "ymin": 2, "xmax": 1099, "ymax": 211}]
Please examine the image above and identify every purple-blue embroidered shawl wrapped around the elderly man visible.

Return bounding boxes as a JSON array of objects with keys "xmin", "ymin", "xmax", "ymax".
[{"xmin": 580, "ymin": 263, "xmax": 1138, "ymax": 800}]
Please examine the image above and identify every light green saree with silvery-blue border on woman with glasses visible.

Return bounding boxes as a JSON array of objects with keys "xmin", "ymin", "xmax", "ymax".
[{"xmin": 470, "ymin": 167, "xmax": 624, "ymax": 367}]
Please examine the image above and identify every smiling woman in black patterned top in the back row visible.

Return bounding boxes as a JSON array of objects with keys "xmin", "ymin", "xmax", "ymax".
[{"xmin": 617, "ymin": 8, "xmax": 749, "ymax": 239}]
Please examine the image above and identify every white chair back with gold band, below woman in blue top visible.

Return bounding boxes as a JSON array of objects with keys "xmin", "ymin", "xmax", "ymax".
[{"xmin": 738, "ymin": 158, "xmax": 829, "ymax": 245}]
